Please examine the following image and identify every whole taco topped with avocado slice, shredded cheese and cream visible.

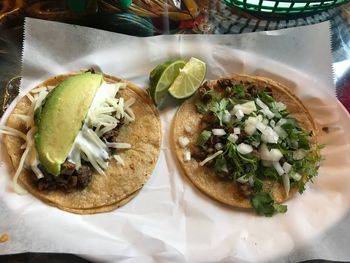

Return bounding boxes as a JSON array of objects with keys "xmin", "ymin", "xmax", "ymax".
[{"xmin": 0, "ymin": 72, "xmax": 161, "ymax": 214}]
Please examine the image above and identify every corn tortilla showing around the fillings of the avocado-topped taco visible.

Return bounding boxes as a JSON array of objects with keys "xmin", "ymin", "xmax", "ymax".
[{"xmin": 4, "ymin": 73, "xmax": 161, "ymax": 214}]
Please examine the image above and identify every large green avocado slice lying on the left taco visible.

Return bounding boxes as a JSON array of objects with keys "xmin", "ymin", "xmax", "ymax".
[{"xmin": 34, "ymin": 72, "xmax": 103, "ymax": 176}]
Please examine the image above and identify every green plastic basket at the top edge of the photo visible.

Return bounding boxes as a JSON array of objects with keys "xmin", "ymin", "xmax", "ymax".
[{"xmin": 225, "ymin": 0, "xmax": 350, "ymax": 15}]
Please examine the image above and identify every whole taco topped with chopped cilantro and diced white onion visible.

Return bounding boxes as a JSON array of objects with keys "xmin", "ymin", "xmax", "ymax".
[{"xmin": 172, "ymin": 75, "xmax": 321, "ymax": 216}]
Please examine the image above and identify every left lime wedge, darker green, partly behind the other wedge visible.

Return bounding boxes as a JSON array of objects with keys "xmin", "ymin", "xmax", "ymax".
[{"xmin": 149, "ymin": 60, "xmax": 186, "ymax": 106}]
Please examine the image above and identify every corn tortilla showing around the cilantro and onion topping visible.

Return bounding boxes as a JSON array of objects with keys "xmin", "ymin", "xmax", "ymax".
[{"xmin": 172, "ymin": 75, "xmax": 317, "ymax": 208}]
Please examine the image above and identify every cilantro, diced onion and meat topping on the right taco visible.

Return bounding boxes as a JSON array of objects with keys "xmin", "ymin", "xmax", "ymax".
[{"xmin": 190, "ymin": 79, "xmax": 321, "ymax": 216}]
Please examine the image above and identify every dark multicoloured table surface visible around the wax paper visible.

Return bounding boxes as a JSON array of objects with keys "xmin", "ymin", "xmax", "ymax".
[{"xmin": 0, "ymin": 0, "xmax": 350, "ymax": 262}]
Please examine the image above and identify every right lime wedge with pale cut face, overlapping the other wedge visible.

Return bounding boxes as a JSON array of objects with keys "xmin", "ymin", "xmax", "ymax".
[{"xmin": 169, "ymin": 58, "xmax": 206, "ymax": 99}]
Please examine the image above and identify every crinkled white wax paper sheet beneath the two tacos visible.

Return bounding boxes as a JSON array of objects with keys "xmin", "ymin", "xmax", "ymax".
[{"xmin": 0, "ymin": 18, "xmax": 350, "ymax": 262}]
